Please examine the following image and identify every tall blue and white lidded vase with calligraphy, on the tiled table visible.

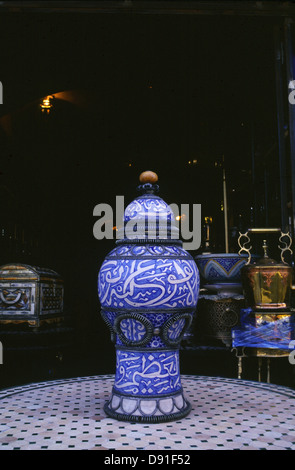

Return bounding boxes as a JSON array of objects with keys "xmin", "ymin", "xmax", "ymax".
[{"xmin": 98, "ymin": 172, "xmax": 200, "ymax": 423}]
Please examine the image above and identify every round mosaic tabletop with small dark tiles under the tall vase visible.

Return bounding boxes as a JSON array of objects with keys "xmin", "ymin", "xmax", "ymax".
[{"xmin": 0, "ymin": 375, "xmax": 295, "ymax": 451}]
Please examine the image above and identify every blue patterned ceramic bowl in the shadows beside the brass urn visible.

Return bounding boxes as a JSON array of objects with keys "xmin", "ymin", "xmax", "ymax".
[{"xmin": 195, "ymin": 253, "xmax": 248, "ymax": 285}]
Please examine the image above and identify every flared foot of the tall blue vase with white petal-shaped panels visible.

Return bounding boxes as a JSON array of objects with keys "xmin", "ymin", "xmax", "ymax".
[{"xmin": 104, "ymin": 391, "xmax": 191, "ymax": 423}]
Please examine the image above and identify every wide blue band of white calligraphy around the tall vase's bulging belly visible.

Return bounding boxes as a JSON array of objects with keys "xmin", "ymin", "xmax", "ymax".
[{"xmin": 98, "ymin": 259, "xmax": 200, "ymax": 308}]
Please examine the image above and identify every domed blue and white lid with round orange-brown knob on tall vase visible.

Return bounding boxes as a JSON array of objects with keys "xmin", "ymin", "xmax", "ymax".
[{"xmin": 119, "ymin": 171, "xmax": 179, "ymax": 242}]
